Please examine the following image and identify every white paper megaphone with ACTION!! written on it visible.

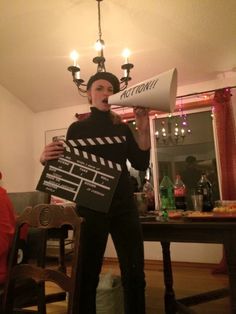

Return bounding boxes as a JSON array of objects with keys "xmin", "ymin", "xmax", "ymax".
[{"xmin": 108, "ymin": 68, "xmax": 177, "ymax": 112}]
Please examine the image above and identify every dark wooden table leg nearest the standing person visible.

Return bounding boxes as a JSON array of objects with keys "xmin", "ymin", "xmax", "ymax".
[{"xmin": 161, "ymin": 242, "xmax": 176, "ymax": 314}]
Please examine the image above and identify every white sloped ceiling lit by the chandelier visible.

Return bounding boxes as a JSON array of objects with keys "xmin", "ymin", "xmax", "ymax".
[{"xmin": 0, "ymin": 0, "xmax": 236, "ymax": 112}]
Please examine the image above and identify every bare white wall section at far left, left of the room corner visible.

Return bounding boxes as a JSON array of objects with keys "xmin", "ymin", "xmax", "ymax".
[{"xmin": 0, "ymin": 86, "xmax": 34, "ymax": 192}]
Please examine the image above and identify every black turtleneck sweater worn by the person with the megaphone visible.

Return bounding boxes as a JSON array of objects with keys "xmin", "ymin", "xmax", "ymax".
[{"xmin": 67, "ymin": 107, "xmax": 150, "ymax": 214}]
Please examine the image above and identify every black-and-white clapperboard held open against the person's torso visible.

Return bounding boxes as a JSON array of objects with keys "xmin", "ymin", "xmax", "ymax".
[{"xmin": 36, "ymin": 136, "xmax": 126, "ymax": 212}]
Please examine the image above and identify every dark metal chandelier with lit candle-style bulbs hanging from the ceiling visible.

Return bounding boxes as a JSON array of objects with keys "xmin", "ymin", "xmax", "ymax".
[{"xmin": 68, "ymin": 0, "xmax": 134, "ymax": 96}]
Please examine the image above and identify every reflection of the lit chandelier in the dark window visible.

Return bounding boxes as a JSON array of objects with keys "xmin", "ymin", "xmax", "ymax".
[{"xmin": 155, "ymin": 114, "xmax": 191, "ymax": 145}]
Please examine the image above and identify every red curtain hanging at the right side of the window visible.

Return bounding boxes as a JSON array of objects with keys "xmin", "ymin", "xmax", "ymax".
[{"xmin": 214, "ymin": 88, "xmax": 236, "ymax": 200}]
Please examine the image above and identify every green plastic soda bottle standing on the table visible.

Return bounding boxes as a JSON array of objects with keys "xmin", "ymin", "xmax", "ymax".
[{"xmin": 160, "ymin": 175, "xmax": 175, "ymax": 211}]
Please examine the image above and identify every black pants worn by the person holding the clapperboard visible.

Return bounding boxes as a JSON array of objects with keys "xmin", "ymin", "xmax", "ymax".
[{"xmin": 78, "ymin": 208, "xmax": 145, "ymax": 314}]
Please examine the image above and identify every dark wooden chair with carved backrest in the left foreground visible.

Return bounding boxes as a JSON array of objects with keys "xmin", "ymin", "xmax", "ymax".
[{"xmin": 3, "ymin": 204, "xmax": 83, "ymax": 314}]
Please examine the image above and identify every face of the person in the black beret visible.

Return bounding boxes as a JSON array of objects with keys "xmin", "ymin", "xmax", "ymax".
[{"xmin": 88, "ymin": 80, "xmax": 114, "ymax": 111}]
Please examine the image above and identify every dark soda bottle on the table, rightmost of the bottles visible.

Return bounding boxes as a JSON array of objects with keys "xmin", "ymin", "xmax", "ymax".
[{"xmin": 197, "ymin": 173, "xmax": 214, "ymax": 212}]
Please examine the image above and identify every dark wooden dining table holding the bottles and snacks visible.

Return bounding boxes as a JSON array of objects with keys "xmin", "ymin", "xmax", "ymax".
[{"xmin": 141, "ymin": 217, "xmax": 236, "ymax": 314}]
